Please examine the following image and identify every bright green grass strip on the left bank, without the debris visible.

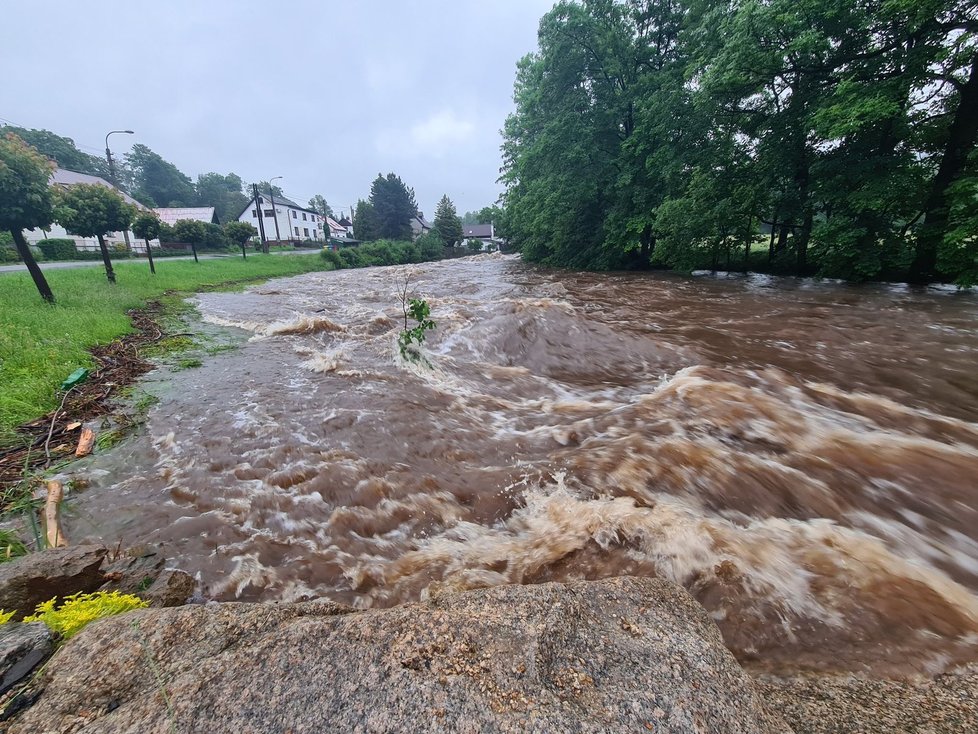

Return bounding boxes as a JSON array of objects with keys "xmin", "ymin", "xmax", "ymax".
[{"xmin": 0, "ymin": 254, "xmax": 330, "ymax": 444}]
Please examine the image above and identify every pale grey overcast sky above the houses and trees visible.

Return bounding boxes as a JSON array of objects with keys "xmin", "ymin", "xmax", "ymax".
[{"xmin": 0, "ymin": 0, "xmax": 553, "ymax": 218}]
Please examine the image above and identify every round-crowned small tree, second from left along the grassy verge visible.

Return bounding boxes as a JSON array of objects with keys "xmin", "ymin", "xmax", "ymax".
[{"xmin": 55, "ymin": 184, "xmax": 136, "ymax": 283}]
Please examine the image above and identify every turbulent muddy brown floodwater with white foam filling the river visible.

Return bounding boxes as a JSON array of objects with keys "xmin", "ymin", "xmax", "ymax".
[{"xmin": 70, "ymin": 256, "xmax": 978, "ymax": 672}]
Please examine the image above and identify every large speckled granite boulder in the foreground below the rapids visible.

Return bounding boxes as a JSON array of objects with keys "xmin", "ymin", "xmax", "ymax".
[{"xmin": 3, "ymin": 578, "xmax": 787, "ymax": 734}]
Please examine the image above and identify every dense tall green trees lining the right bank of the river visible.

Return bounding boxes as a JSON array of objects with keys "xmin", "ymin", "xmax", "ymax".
[{"xmin": 503, "ymin": 0, "xmax": 978, "ymax": 282}]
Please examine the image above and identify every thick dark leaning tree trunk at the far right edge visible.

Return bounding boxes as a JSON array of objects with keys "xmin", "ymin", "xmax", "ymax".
[{"xmin": 910, "ymin": 56, "xmax": 978, "ymax": 283}]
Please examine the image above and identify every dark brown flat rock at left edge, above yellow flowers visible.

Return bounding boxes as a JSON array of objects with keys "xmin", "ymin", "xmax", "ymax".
[{"xmin": 0, "ymin": 545, "xmax": 108, "ymax": 620}]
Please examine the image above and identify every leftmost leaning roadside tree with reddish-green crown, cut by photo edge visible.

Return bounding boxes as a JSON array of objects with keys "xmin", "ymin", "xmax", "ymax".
[{"xmin": 0, "ymin": 133, "xmax": 54, "ymax": 303}]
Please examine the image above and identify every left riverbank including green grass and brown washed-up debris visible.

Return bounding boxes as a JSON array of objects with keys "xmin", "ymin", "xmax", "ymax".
[{"xmin": 0, "ymin": 255, "xmax": 344, "ymax": 512}]
